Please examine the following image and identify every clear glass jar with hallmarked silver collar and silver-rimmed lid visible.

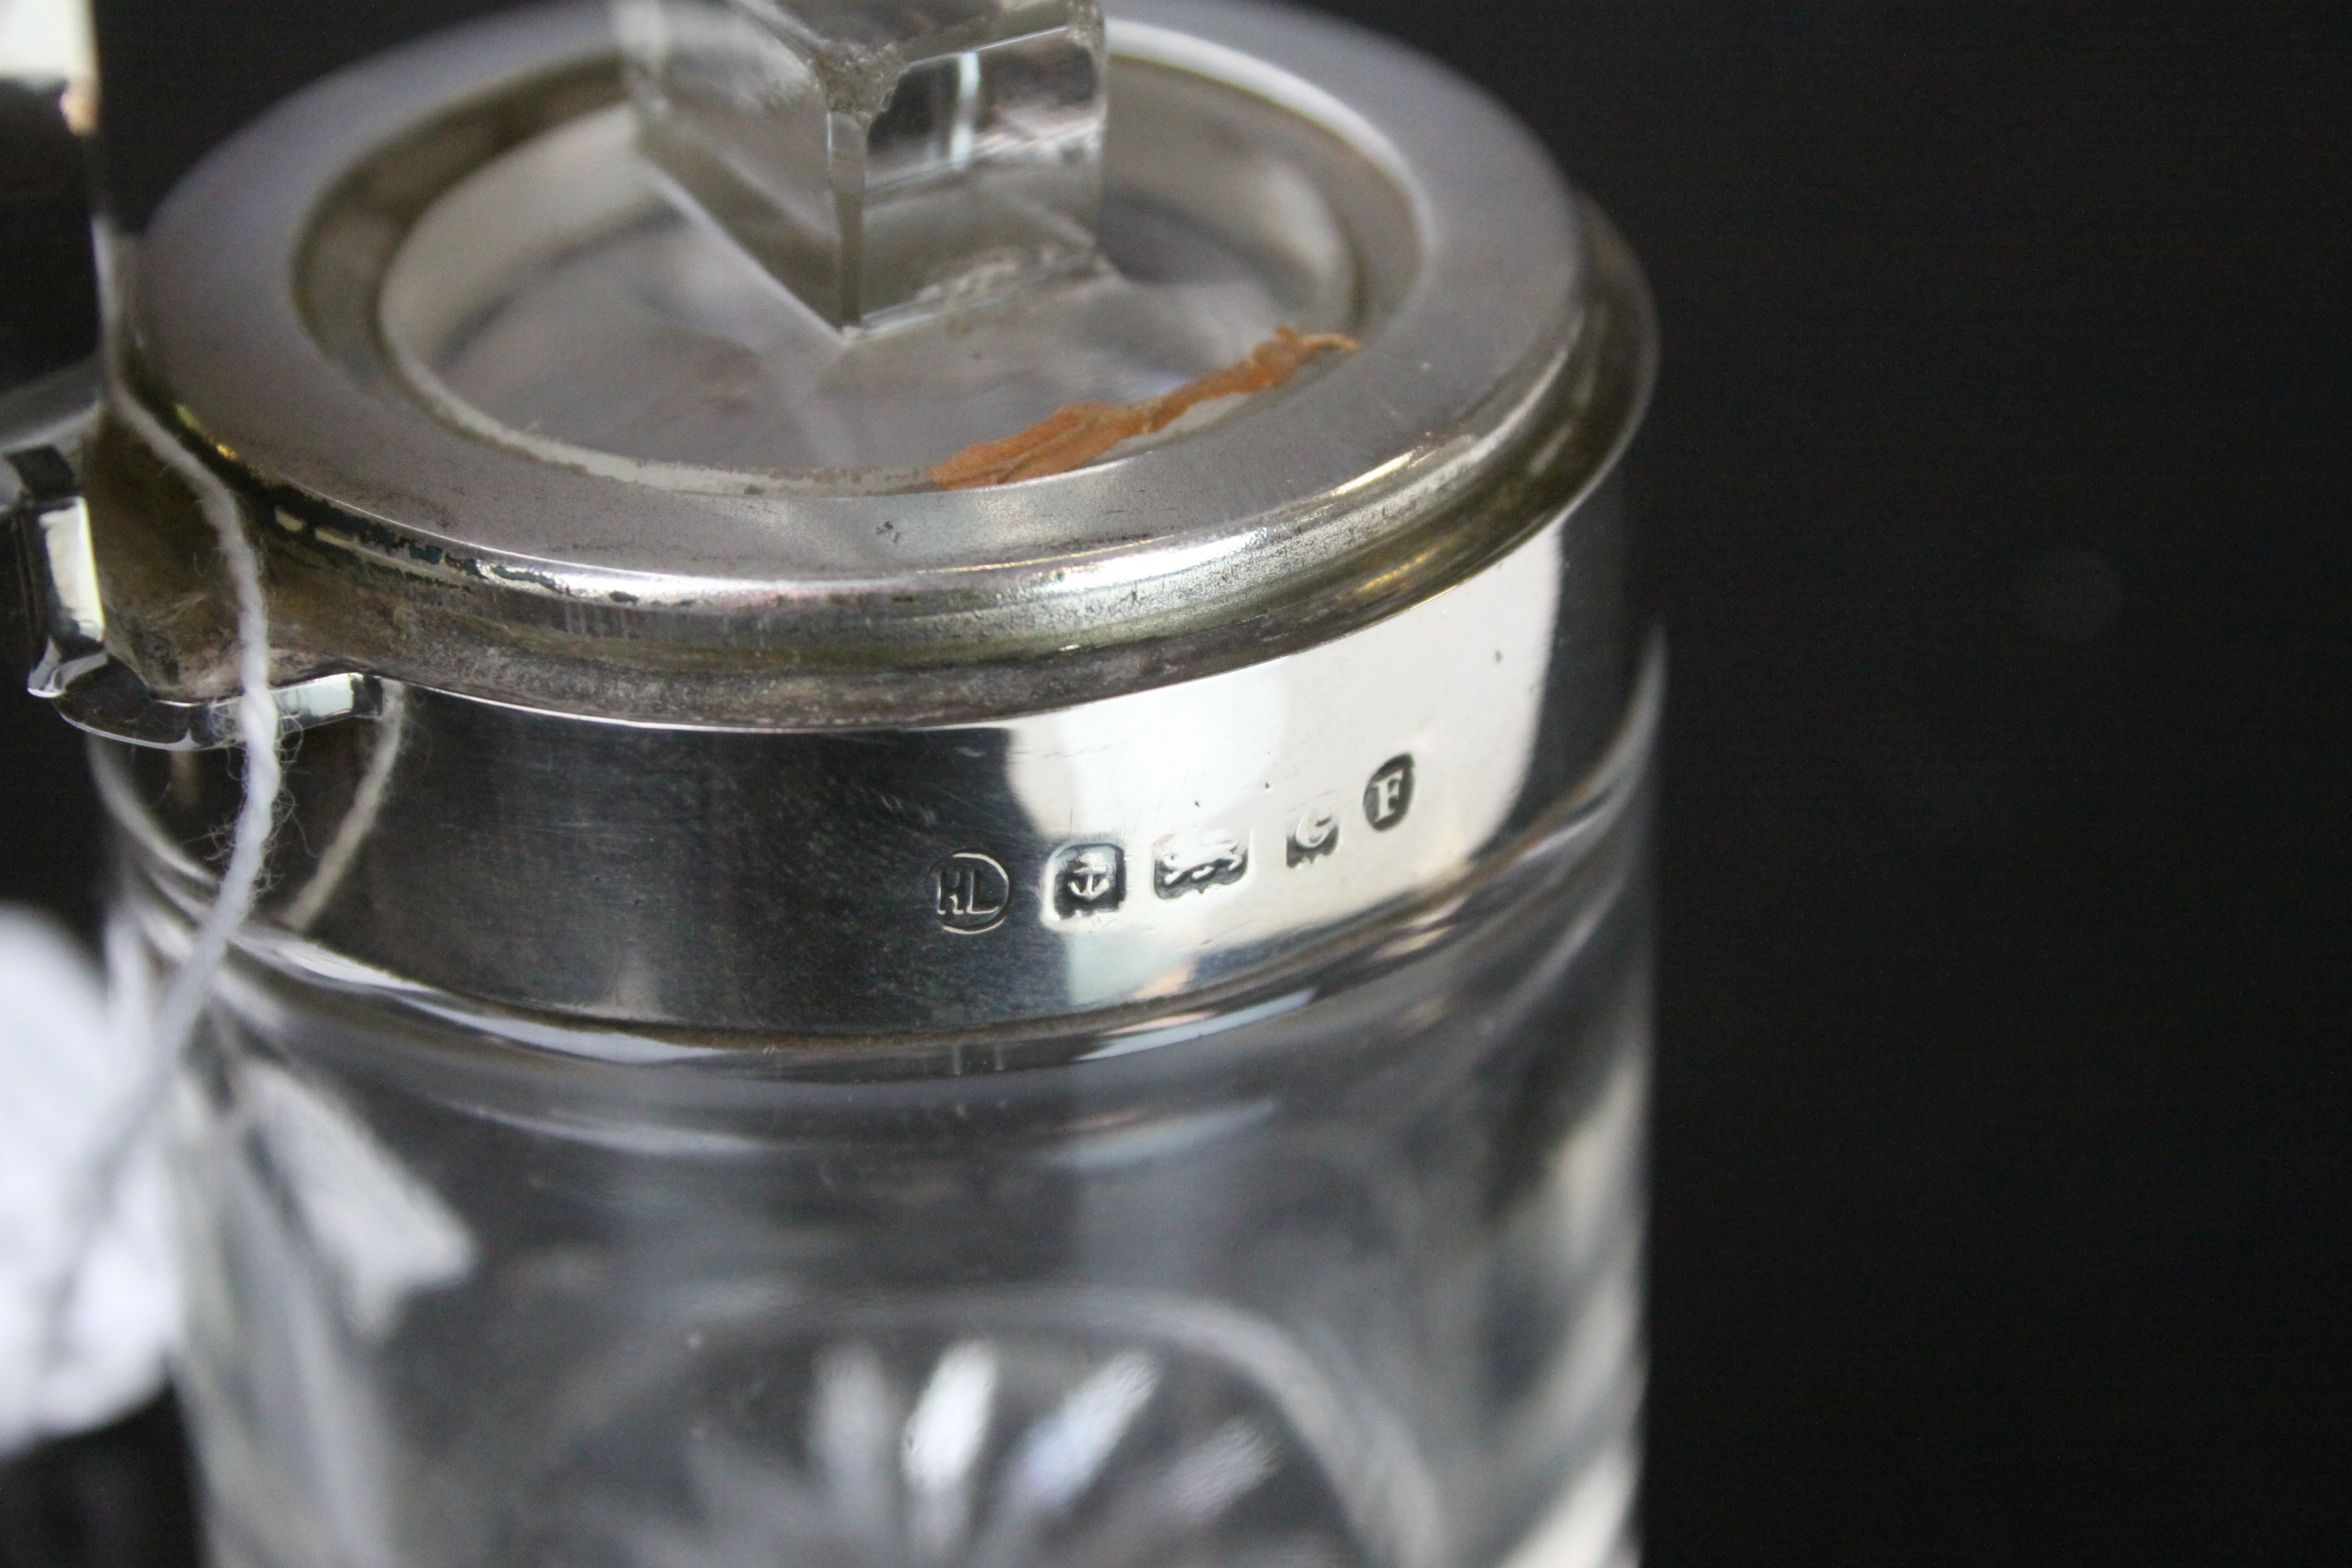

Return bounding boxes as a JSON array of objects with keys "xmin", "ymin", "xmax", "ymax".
[{"xmin": 12, "ymin": 0, "xmax": 1661, "ymax": 1568}]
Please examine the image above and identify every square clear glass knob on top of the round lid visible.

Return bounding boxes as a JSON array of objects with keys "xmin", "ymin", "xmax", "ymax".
[{"xmin": 614, "ymin": 0, "xmax": 1105, "ymax": 329}]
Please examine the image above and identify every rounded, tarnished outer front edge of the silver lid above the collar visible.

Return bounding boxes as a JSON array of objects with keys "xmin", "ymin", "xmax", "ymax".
[{"xmin": 125, "ymin": 212, "xmax": 1658, "ymax": 731}]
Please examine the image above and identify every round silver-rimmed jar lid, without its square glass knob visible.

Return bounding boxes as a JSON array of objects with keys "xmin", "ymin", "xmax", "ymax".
[{"xmin": 94, "ymin": 0, "xmax": 1646, "ymax": 726}]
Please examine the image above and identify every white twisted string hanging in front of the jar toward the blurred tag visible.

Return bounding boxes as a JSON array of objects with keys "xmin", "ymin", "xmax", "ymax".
[{"xmin": 40, "ymin": 386, "xmax": 285, "ymax": 1401}]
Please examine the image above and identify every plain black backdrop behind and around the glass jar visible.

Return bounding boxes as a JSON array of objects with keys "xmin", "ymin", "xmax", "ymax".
[{"xmin": 0, "ymin": 0, "xmax": 2352, "ymax": 1568}]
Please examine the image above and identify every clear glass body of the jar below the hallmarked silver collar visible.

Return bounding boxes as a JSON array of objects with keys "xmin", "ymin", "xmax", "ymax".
[{"xmin": 125, "ymin": 802, "xmax": 1649, "ymax": 1568}]
